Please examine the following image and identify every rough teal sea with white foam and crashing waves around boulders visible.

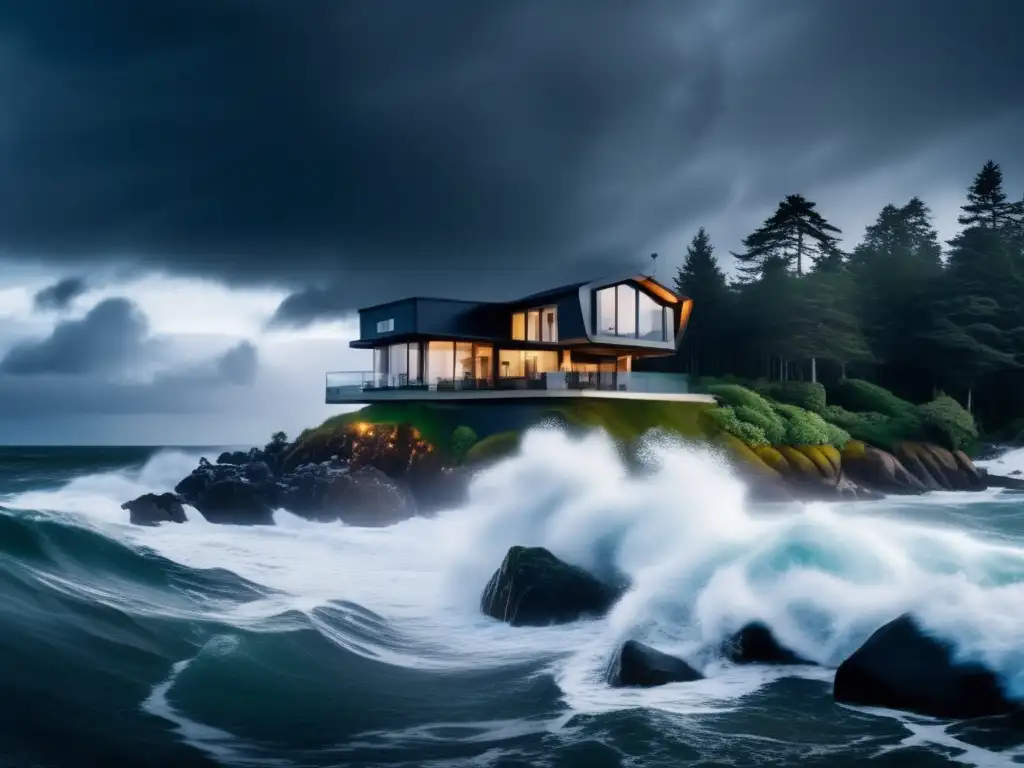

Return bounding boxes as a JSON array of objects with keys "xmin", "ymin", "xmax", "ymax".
[{"xmin": 0, "ymin": 431, "xmax": 1024, "ymax": 768}]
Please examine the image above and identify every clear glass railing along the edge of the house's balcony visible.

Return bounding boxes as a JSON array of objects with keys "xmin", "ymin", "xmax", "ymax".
[{"xmin": 327, "ymin": 371, "xmax": 689, "ymax": 399}]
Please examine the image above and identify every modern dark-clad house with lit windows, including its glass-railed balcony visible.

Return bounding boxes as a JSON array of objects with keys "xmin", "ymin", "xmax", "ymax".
[{"xmin": 327, "ymin": 273, "xmax": 702, "ymax": 403}]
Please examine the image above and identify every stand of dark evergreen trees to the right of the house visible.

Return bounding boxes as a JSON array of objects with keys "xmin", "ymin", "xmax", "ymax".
[{"xmin": 655, "ymin": 161, "xmax": 1024, "ymax": 434}]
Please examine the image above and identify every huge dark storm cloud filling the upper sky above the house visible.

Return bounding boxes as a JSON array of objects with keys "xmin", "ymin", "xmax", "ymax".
[{"xmin": 0, "ymin": 0, "xmax": 1024, "ymax": 322}]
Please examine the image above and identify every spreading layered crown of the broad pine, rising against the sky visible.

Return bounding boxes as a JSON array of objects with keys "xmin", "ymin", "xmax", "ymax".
[{"xmin": 732, "ymin": 195, "xmax": 843, "ymax": 280}]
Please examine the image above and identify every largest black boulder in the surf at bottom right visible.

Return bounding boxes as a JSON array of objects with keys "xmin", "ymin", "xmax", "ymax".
[{"xmin": 834, "ymin": 614, "xmax": 1015, "ymax": 719}]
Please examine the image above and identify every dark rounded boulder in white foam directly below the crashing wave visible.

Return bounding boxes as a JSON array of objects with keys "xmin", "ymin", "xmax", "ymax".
[{"xmin": 480, "ymin": 547, "xmax": 622, "ymax": 627}]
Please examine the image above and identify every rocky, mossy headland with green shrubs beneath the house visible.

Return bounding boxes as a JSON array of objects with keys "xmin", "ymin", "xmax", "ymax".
[{"xmin": 124, "ymin": 380, "xmax": 1024, "ymax": 525}]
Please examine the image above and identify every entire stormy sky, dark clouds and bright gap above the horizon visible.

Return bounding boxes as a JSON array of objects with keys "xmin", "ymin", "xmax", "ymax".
[{"xmin": 0, "ymin": 0, "xmax": 1024, "ymax": 444}]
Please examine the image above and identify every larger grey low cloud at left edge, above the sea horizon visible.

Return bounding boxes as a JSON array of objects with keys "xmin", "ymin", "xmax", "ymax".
[{"xmin": 0, "ymin": 298, "xmax": 148, "ymax": 376}]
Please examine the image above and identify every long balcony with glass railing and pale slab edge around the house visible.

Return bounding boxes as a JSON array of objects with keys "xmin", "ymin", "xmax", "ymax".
[{"xmin": 327, "ymin": 371, "xmax": 708, "ymax": 403}]
